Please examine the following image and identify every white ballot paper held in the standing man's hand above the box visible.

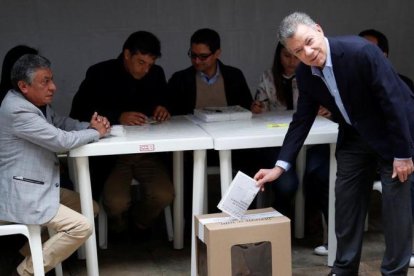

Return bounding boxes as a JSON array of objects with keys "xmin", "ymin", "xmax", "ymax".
[{"xmin": 217, "ymin": 171, "xmax": 259, "ymax": 220}]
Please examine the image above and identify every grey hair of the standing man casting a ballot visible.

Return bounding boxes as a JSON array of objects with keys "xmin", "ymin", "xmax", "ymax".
[{"xmin": 278, "ymin": 12, "xmax": 316, "ymax": 46}]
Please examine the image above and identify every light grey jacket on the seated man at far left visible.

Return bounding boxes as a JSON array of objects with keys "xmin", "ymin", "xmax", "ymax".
[{"xmin": 0, "ymin": 90, "xmax": 99, "ymax": 224}]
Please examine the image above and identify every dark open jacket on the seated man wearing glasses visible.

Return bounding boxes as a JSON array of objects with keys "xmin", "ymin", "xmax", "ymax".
[{"xmin": 168, "ymin": 61, "xmax": 252, "ymax": 115}]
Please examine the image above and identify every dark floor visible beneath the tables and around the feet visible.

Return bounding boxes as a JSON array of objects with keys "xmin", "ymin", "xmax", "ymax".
[{"xmin": 55, "ymin": 221, "xmax": 414, "ymax": 276}]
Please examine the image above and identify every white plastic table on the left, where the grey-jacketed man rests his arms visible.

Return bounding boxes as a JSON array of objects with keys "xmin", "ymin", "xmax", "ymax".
[{"xmin": 69, "ymin": 116, "xmax": 213, "ymax": 276}]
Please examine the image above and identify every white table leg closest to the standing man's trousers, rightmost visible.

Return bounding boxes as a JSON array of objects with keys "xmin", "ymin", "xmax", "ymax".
[{"xmin": 328, "ymin": 144, "xmax": 336, "ymax": 266}]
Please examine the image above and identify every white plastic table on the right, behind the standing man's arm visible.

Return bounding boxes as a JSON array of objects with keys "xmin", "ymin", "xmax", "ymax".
[{"xmin": 198, "ymin": 111, "xmax": 338, "ymax": 265}]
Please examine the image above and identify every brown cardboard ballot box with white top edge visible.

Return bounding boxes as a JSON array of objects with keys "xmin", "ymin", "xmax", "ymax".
[{"xmin": 194, "ymin": 208, "xmax": 292, "ymax": 276}]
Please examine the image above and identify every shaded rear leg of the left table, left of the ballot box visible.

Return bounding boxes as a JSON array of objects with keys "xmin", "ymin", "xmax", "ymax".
[{"xmin": 173, "ymin": 151, "xmax": 184, "ymax": 249}]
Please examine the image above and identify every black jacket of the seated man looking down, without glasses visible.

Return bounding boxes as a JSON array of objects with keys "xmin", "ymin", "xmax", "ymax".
[{"xmin": 70, "ymin": 55, "xmax": 167, "ymax": 125}]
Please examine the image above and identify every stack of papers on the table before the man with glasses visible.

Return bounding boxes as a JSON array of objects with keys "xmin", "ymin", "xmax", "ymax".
[{"xmin": 194, "ymin": 105, "xmax": 252, "ymax": 122}]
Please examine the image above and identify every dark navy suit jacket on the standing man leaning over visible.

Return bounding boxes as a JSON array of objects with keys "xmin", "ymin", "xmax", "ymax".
[{"xmin": 279, "ymin": 36, "xmax": 414, "ymax": 163}]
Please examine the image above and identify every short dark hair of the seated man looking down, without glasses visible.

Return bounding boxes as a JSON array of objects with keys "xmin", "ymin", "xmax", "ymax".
[{"xmin": 122, "ymin": 31, "xmax": 161, "ymax": 58}]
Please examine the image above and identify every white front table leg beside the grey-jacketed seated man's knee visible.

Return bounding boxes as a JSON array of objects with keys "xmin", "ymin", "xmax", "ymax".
[{"xmin": 75, "ymin": 157, "xmax": 99, "ymax": 276}]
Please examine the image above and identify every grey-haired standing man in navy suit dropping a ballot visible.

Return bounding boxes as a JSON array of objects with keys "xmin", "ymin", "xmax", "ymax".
[{"xmin": 255, "ymin": 12, "xmax": 414, "ymax": 275}]
